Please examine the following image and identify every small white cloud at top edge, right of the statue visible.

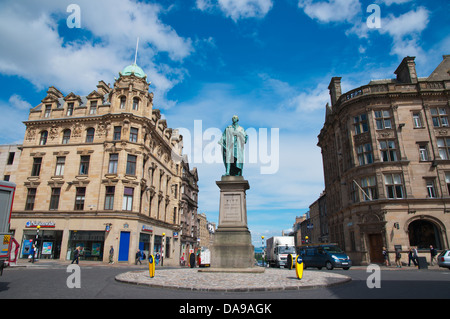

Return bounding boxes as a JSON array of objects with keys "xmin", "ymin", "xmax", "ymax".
[{"xmin": 298, "ymin": 0, "xmax": 362, "ymax": 23}]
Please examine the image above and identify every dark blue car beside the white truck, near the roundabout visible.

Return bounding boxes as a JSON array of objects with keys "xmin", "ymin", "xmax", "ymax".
[{"xmin": 300, "ymin": 244, "xmax": 352, "ymax": 270}]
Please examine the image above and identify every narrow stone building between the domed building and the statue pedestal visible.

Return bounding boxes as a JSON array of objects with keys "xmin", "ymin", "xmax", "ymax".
[{"xmin": 180, "ymin": 155, "xmax": 199, "ymax": 260}]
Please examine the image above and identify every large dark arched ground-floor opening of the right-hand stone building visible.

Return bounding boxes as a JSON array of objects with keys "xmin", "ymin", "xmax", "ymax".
[{"xmin": 408, "ymin": 219, "xmax": 442, "ymax": 249}]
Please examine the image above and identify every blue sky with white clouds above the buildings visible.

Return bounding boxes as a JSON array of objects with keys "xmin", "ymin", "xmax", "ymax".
[{"xmin": 0, "ymin": 0, "xmax": 450, "ymax": 246}]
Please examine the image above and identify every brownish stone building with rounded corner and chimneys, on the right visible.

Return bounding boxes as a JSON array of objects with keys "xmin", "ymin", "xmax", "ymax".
[{"xmin": 318, "ymin": 55, "xmax": 450, "ymax": 264}]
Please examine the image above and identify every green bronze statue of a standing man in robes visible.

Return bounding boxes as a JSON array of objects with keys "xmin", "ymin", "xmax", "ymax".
[{"xmin": 219, "ymin": 115, "xmax": 248, "ymax": 176}]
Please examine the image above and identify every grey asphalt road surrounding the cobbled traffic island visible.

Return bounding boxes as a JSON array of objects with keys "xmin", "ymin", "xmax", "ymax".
[{"xmin": 0, "ymin": 264, "xmax": 450, "ymax": 300}]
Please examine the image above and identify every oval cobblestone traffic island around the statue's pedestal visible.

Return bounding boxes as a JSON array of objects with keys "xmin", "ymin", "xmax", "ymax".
[{"xmin": 116, "ymin": 268, "xmax": 351, "ymax": 292}]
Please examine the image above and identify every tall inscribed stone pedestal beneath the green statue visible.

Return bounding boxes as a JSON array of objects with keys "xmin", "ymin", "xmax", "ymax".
[{"xmin": 209, "ymin": 176, "xmax": 264, "ymax": 272}]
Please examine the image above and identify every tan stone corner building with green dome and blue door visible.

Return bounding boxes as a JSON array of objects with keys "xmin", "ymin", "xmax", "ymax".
[{"xmin": 11, "ymin": 64, "xmax": 182, "ymax": 265}]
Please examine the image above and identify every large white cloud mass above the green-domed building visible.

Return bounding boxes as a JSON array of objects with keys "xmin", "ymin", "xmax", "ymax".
[{"xmin": 0, "ymin": 0, "xmax": 194, "ymax": 107}]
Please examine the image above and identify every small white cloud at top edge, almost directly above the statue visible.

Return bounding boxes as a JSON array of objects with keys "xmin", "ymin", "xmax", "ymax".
[{"xmin": 196, "ymin": 0, "xmax": 273, "ymax": 22}]
